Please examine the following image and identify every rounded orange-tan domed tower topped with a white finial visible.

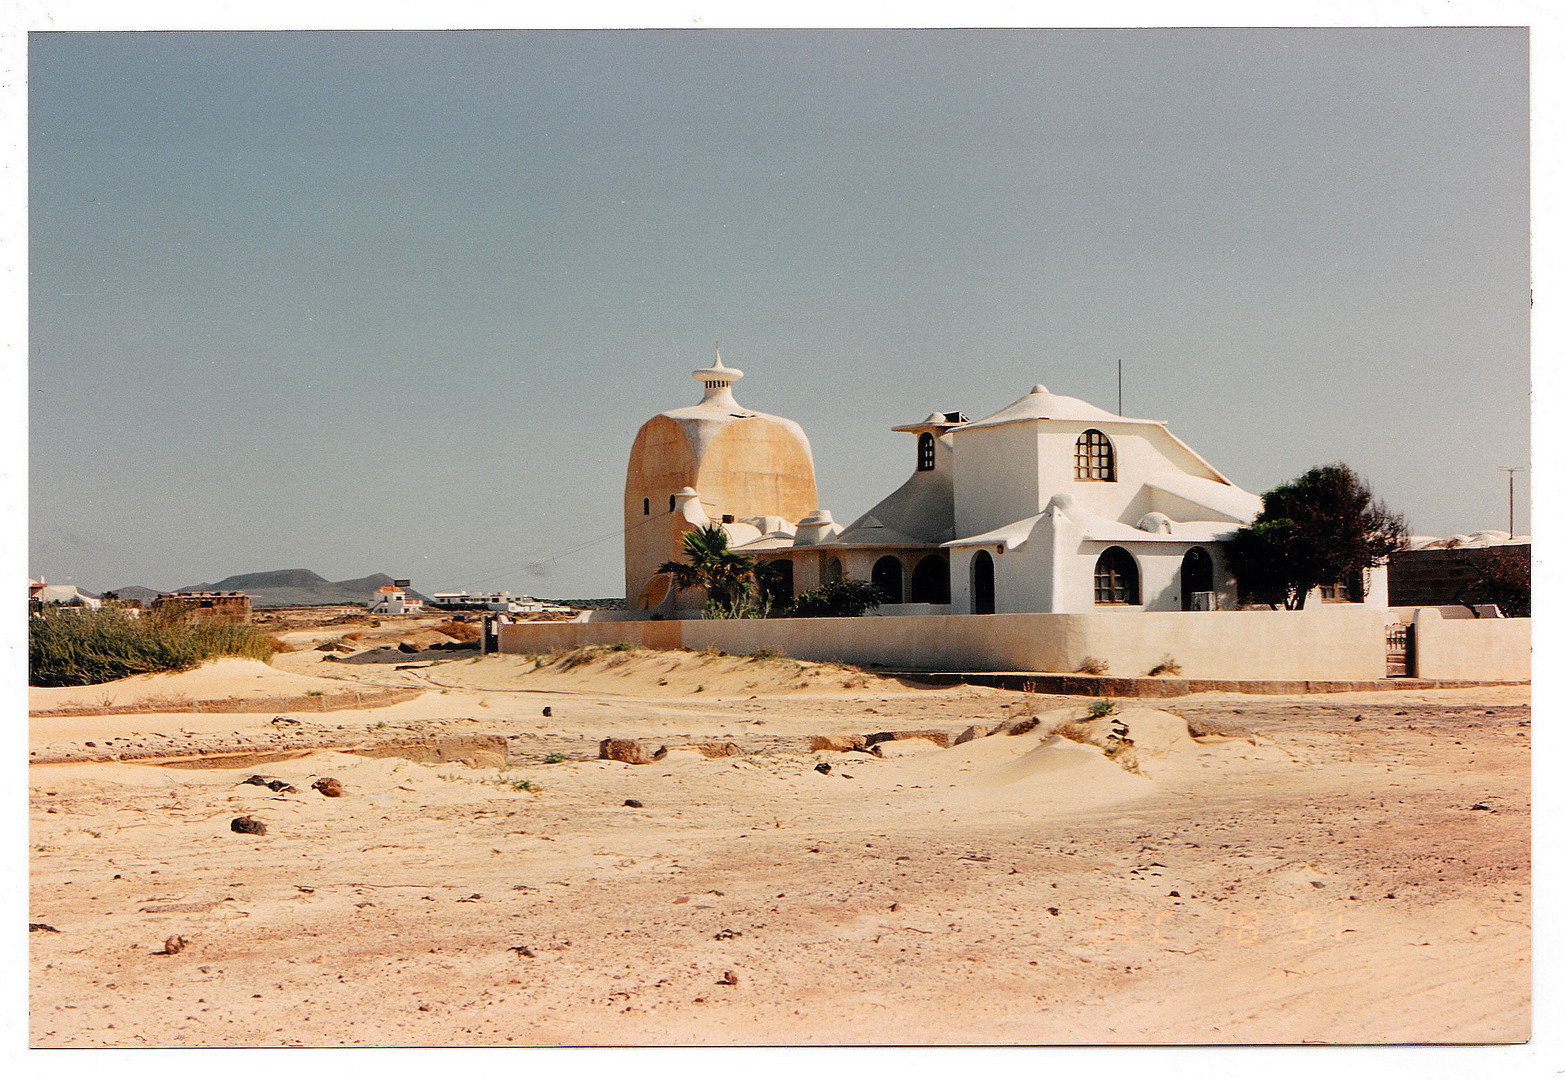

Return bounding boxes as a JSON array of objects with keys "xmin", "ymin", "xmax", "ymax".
[{"xmin": 624, "ymin": 354, "xmax": 829, "ymax": 614}]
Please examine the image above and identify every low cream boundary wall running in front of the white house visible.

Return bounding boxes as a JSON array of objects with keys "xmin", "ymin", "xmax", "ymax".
[{"xmin": 495, "ymin": 606, "xmax": 1446, "ymax": 681}]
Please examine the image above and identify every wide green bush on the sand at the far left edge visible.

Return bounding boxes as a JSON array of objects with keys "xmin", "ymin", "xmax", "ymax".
[{"xmin": 27, "ymin": 607, "xmax": 275, "ymax": 686}]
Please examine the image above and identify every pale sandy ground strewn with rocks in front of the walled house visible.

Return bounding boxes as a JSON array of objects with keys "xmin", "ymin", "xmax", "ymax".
[{"xmin": 30, "ymin": 651, "xmax": 1531, "ymax": 1047}]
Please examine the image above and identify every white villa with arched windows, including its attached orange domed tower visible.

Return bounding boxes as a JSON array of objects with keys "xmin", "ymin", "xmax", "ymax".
[{"xmin": 626, "ymin": 360, "xmax": 1385, "ymax": 617}]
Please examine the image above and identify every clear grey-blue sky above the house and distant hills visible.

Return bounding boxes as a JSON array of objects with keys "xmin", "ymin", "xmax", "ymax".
[{"xmin": 27, "ymin": 28, "xmax": 1532, "ymax": 598}]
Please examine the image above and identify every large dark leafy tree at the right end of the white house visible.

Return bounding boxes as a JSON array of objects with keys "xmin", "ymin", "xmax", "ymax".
[{"xmin": 1229, "ymin": 462, "xmax": 1407, "ymax": 610}]
